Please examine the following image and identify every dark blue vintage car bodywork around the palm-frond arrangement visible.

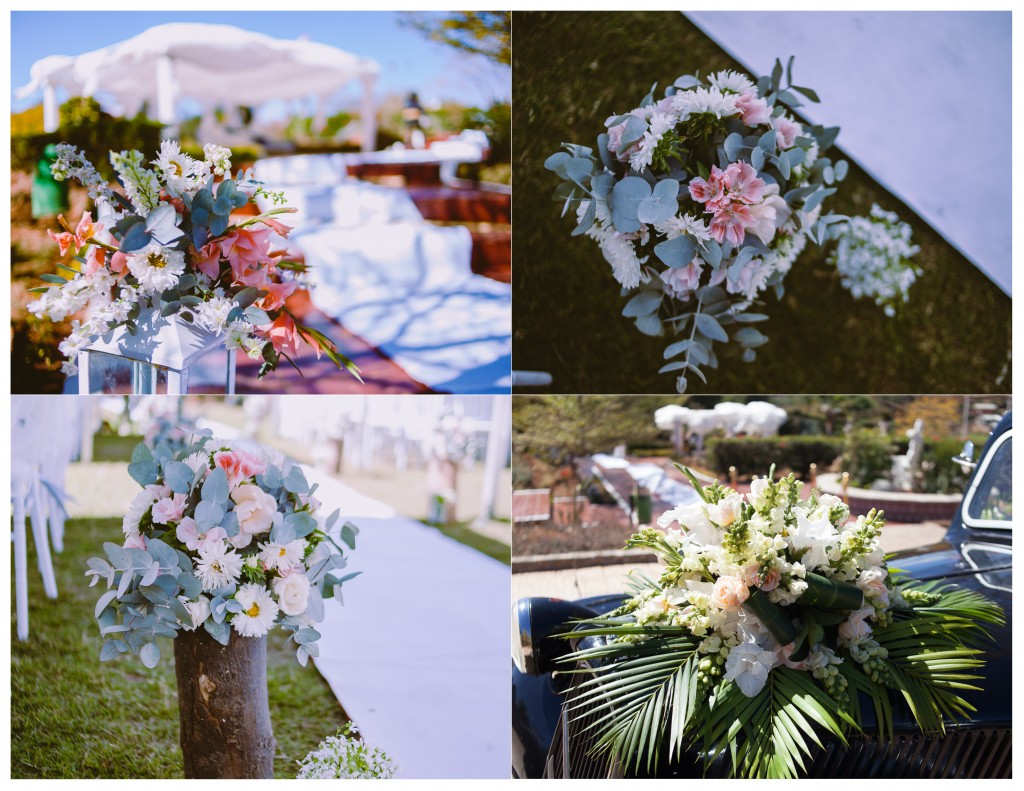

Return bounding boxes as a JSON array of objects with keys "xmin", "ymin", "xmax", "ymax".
[{"xmin": 512, "ymin": 414, "xmax": 1013, "ymax": 778}]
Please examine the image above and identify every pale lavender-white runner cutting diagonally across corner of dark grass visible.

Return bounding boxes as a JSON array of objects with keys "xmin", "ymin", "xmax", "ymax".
[{"xmin": 686, "ymin": 11, "xmax": 1012, "ymax": 294}]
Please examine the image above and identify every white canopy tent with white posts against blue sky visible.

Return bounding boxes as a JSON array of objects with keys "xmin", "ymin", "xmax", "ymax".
[{"xmin": 16, "ymin": 23, "xmax": 380, "ymax": 151}]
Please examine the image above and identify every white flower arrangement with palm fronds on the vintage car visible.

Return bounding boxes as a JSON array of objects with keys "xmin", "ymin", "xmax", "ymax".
[{"xmin": 562, "ymin": 468, "xmax": 1005, "ymax": 778}]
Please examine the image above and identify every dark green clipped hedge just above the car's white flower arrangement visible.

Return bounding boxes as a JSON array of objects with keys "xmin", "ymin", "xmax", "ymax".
[{"xmin": 708, "ymin": 435, "xmax": 843, "ymax": 475}]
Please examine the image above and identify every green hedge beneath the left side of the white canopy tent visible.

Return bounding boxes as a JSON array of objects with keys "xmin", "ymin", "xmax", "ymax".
[{"xmin": 10, "ymin": 97, "xmax": 163, "ymax": 177}]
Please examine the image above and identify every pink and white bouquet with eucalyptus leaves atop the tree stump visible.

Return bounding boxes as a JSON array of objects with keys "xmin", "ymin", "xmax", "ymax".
[{"xmin": 86, "ymin": 431, "xmax": 358, "ymax": 667}]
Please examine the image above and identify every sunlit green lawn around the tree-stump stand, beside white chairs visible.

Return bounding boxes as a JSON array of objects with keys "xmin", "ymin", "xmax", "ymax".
[{"xmin": 11, "ymin": 519, "xmax": 347, "ymax": 778}]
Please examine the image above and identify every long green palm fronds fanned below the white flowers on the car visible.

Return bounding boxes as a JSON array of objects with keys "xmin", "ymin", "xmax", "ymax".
[{"xmin": 560, "ymin": 582, "xmax": 1005, "ymax": 779}]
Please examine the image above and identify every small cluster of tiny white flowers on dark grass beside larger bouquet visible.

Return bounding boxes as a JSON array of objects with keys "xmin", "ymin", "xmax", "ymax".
[{"xmin": 828, "ymin": 204, "xmax": 921, "ymax": 317}]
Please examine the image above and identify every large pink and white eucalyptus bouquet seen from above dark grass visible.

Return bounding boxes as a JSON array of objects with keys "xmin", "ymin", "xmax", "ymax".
[{"xmin": 545, "ymin": 58, "xmax": 848, "ymax": 392}]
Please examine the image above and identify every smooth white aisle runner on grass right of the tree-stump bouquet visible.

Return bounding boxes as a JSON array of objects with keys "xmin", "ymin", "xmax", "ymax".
[{"xmin": 306, "ymin": 467, "xmax": 512, "ymax": 779}]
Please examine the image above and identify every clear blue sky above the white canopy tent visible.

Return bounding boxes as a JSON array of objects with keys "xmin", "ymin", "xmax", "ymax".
[{"xmin": 11, "ymin": 11, "xmax": 512, "ymax": 112}]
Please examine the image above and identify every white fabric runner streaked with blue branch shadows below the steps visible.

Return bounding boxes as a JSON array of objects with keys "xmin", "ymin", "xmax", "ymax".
[{"xmin": 292, "ymin": 222, "xmax": 512, "ymax": 394}]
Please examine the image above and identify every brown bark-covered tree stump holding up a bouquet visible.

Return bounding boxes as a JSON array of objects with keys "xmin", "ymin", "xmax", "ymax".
[{"xmin": 174, "ymin": 629, "xmax": 278, "ymax": 779}]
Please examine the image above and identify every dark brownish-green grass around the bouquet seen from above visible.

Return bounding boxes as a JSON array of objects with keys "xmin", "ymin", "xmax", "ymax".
[{"xmin": 512, "ymin": 11, "xmax": 1011, "ymax": 393}]
